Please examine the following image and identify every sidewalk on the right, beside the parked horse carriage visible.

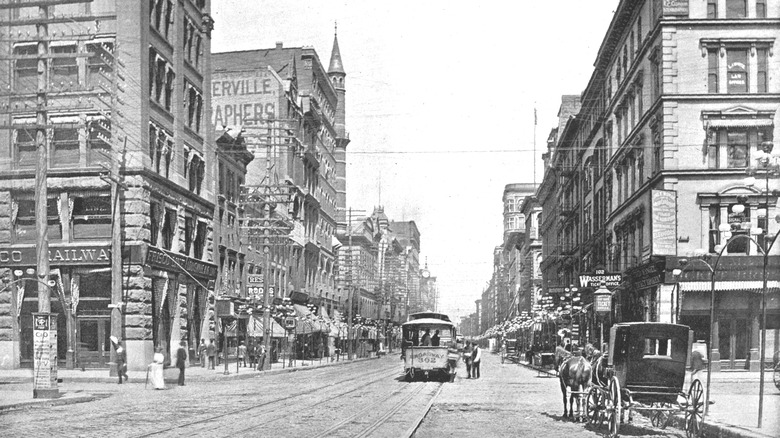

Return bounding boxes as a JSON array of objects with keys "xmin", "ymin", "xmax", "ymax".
[{"xmin": 518, "ymin": 361, "xmax": 780, "ymax": 438}]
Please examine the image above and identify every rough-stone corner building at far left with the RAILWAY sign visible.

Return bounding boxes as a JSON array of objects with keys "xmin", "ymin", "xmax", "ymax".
[{"xmin": 0, "ymin": 0, "xmax": 217, "ymax": 369}]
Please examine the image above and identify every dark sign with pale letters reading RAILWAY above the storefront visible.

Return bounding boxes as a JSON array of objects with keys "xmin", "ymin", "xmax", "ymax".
[{"xmin": 0, "ymin": 245, "xmax": 111, "ymax": 266}]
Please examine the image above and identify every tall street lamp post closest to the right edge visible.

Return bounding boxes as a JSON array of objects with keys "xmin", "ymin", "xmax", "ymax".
[{"xmin": 745, "ymin": 141, "xmax": 780, "ymax": 429}]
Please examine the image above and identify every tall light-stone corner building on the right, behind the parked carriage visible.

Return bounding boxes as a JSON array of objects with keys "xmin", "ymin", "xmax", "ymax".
[{"xmin": 540, "ymin": 0, "xmax": 780, "ymax": 370}]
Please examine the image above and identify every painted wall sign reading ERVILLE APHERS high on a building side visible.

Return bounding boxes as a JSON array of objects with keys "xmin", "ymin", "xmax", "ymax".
[{"xmin": 211, "ymin": 70, "xmax": 284, "ymax": 127}]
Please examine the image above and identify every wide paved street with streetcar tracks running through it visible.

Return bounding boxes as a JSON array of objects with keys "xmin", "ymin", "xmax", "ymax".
[{"xmin": 0, "ymin": 354, "xmax": 716, "ymax": 438}]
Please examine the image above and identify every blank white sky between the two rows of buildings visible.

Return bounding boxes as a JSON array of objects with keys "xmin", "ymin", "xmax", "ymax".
[{"xmin": 212, "ymin": 0, "xmax": 618, "ymax": 317}]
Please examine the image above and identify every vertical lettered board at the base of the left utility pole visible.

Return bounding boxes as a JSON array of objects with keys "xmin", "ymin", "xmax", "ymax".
[{"xmin": 32, "ymin": 313, "xmax": 58, "ymax": 398}]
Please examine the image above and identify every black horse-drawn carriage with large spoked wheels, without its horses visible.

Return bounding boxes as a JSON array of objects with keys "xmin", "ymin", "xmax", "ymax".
[{"xmin": 586, "ymin": 322, "xmax": 704, "ymax": 437}]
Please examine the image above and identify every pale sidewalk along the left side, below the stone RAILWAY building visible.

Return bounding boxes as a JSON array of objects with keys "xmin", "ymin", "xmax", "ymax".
[{"xmin": 0, "ymin": 356, "xmax": 377, "ymax": 413}]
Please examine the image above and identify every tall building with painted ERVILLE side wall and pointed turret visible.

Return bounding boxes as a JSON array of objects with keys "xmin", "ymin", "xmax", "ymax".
[{"xmin": 212, "ymin": 37, "xmax": 348, "ymax": 317}]
